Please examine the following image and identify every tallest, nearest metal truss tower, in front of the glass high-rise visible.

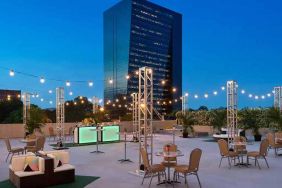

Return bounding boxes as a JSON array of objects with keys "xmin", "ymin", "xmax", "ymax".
[{"xmin": 138, "ymin": 67, "xmax": 154, "ymax": 166}]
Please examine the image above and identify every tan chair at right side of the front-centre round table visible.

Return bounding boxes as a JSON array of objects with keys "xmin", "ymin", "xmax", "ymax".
[{"xmin": 173, "ymin": 148, "xmax": 202, "ymax": 187}]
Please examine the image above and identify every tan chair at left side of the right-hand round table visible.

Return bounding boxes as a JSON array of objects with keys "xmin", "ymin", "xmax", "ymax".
[{"xmin": 217, "ymin": 139, "xmax": 239, "ymax": 169}]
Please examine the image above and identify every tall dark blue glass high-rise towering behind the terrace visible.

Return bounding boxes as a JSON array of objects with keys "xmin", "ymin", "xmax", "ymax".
[{"xmin": 104, "ymin": 0, "xmax": 182, "ymax": 117}]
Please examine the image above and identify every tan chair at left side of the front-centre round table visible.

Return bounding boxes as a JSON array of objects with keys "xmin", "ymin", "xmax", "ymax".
[{"xmin": 141, "ymin": 148, "xmax": 166, "ymax": 187}]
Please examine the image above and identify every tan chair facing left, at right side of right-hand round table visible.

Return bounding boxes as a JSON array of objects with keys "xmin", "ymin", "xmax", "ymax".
[{"xmin": 247, "ymin": 139, "xmax": 269, "ymax": 169}]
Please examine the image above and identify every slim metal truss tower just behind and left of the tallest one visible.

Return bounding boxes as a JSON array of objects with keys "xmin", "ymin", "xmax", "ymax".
[{"xmin": 131, "ymin": 93, "xmax": 139, "ymax": 142}]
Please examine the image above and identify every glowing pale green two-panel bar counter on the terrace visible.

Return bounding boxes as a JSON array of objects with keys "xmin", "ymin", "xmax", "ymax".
[{"xmin": 74, "ymin": 125, "xmax": 120, "ymax": 144}]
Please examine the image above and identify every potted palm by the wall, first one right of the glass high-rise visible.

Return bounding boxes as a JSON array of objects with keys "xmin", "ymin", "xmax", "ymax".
[{"xmin": 176, "ymin": 112, "xmax": 195, "ymax": 138}]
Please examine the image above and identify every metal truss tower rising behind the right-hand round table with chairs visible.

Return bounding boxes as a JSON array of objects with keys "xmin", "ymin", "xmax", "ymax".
[{"xmin": 226, "ymin": 80, "xmax": 238, "ymax": 143}]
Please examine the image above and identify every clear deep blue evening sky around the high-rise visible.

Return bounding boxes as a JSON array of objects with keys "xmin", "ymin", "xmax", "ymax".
[{"xmin": 0, "ymin": 0, "xmax": 282, "ymax": 108}]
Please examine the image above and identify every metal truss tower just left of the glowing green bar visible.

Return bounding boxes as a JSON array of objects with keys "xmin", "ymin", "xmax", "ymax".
[{"xmin": 56, "ymin": 87, "xmax": 65, "ymax": 147}]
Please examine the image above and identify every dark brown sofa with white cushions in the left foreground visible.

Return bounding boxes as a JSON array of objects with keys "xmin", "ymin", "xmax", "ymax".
[{"xmin": 9, "ymin": 151, "xmax": 75, "ymax": 188}]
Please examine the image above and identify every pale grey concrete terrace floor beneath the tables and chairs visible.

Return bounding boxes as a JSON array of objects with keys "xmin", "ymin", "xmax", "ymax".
[{"xmin": 0, "ymin": 135, "xmax": 282, "ymax": 188}]
